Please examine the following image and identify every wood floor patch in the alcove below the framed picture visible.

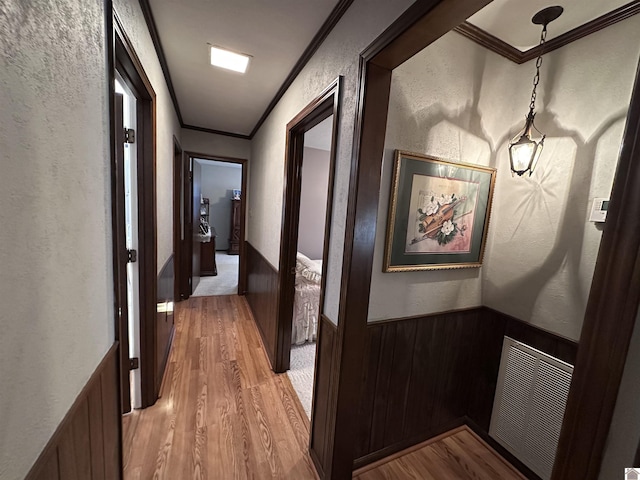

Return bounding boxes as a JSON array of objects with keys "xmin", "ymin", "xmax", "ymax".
[{"xmin": 353, "ymin": 426, "xmax": 525, "ymax": 480}]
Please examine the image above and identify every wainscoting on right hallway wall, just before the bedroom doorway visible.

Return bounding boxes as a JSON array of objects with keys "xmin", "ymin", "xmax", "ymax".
[{"xmin": 245, "ymin": 242, "xmax": 278, "ymax": 368}]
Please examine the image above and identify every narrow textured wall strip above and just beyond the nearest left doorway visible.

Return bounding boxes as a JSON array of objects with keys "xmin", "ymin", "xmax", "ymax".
[{"xmin": 113, "ymin": 0, "xmax": 181, "ymax": 272}]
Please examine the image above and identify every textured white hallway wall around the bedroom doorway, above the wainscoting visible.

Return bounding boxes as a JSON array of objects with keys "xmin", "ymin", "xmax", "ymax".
[{"xmin": 247, "ymin": 0, "xmax": 412, "ymax": 322}]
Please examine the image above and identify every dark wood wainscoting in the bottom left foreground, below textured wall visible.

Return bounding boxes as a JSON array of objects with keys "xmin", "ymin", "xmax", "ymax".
[{"xmin": 25, "ymin": 341, "xmax": 122, "ymax": 480}]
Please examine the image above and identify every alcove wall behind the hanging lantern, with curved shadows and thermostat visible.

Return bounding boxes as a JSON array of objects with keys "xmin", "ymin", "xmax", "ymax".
[{"xmin": 483, "ymin": 15, "xmax": 640, "ymax": 340}]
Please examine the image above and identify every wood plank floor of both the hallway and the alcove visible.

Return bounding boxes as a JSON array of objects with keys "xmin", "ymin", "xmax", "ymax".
[{"xmin": 123, "ymin": 295, "xmax": 523, "ymax": 480}]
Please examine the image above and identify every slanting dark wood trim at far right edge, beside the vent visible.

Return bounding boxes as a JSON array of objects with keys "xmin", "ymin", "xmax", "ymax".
[{"xmin": 552, "ymin": 53, "xmax": 640, "ymax": 480}]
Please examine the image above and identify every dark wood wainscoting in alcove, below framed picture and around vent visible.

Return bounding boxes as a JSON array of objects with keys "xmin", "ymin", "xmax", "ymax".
[{"xmin": 354, "ymin": 307, "xmax": 577, "ymax": 474}]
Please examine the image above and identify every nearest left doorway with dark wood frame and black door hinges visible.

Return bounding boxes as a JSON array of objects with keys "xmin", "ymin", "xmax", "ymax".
[{"xmin": 113, "ymin": 15, "xmax": 173, "ymax": 413}]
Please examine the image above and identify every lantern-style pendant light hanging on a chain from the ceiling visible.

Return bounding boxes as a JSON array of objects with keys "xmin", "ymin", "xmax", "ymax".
[{"xmin": 509, "ymin": 6, "xmax": 564, "ymax": 176}]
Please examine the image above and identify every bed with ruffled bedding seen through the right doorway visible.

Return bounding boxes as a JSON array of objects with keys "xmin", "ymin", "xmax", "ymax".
[{"xmin": 291, "ymin": 252, "xmax": 322, "ymax": 345}]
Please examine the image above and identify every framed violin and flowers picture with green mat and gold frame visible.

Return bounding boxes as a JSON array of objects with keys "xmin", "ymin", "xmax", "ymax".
[{"xmin": 382, "ymin": 150, "xmax": 496, "ymax": 272}]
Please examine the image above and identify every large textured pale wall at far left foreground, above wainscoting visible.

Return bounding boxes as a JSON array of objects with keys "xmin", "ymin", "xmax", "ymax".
[{"xmin": 0, "ymin": 0, "xmax": 114, "ymax": 480}]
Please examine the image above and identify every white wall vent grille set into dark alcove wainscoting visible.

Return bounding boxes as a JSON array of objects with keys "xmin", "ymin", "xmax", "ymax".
[{"xmin": 489, "ymin": 337, "xmax": 573, "ymax": 479}]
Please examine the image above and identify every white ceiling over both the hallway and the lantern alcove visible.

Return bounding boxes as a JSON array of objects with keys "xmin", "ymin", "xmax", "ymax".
[{"xmin": 146, "ymin": 0, "xmax": 640, "ymax": 138}]
